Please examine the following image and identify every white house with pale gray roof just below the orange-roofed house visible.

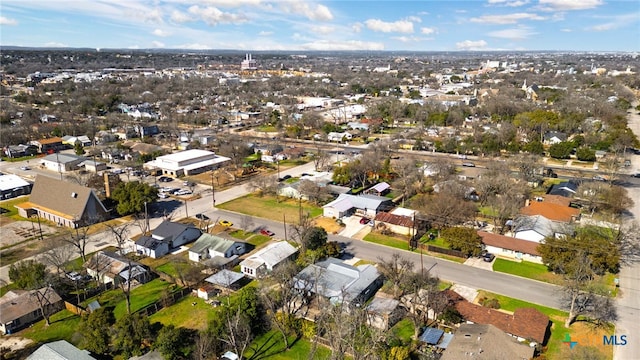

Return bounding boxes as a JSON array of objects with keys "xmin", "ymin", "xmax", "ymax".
[{"xmin": 511, "ymin": 215, "xmax": 574, "ymax": 243}]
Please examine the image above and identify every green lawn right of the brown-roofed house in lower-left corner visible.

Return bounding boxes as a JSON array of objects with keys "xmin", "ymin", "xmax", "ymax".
[{"xmin": 17, "ymin": 310, "xmax": 82, "ymax": 344}]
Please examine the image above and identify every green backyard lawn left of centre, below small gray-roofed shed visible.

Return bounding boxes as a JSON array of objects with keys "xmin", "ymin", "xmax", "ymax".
[{"xmin": 149, "ymin": 296, "xmax": 217, "ymax": 330}]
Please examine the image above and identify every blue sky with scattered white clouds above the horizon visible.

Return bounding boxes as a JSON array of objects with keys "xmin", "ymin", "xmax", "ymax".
[{"xmin": 0, "ymin": 0, "xmax": 640, "ymax": 51}]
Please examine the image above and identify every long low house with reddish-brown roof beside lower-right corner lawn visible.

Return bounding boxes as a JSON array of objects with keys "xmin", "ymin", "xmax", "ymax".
[{"xmin": 445, "ymin": 290, "xmax": 550, "ymax": 344}]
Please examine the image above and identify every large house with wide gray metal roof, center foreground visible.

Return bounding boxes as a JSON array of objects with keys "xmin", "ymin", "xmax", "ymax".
[{"xmin": 293, "ymin": 258, "xmax": 382, "ymax": 305}]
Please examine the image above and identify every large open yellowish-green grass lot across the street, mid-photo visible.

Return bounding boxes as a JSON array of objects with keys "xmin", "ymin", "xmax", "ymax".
[{"xmin": 218, "ymin": 195, "xmax": 322, "ymax": 222}]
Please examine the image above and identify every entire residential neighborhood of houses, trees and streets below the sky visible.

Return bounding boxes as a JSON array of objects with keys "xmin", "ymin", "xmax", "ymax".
[{"xmin": 0, "ymin": 50, "xmax": 640, "ymax": 359}]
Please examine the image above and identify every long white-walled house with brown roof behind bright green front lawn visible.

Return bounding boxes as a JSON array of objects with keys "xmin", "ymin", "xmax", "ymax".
[{"xmin": 478, "ymin": 231, "xmax": 542, "ymax": 264}]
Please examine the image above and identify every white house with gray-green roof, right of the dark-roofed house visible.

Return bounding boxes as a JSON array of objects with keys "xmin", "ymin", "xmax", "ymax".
[{"xmin": 189, "ymin": 234, "xmax": 248, "ymax": 267}]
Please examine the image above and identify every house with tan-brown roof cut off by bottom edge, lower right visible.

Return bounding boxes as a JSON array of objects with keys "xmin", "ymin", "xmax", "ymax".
[{"xmin": 440, "ymin": 324, "xmax": 535, "ymax": 360}]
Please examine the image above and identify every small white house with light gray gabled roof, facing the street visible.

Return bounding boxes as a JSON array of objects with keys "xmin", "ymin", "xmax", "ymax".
[{"xmin": 240, "ymin": 241, "xmax": 298, "ymax": 278}]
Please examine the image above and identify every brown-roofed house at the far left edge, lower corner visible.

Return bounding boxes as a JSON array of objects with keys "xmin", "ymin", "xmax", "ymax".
[{"xmin": 0, "ymin": 287, "xmax": 63, "ymax": 335}]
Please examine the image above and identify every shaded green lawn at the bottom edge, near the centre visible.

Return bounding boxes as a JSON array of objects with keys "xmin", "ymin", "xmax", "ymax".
[{"xmin": 244, "ymin": 331, "xmax": 331, "ymax": 360}]
